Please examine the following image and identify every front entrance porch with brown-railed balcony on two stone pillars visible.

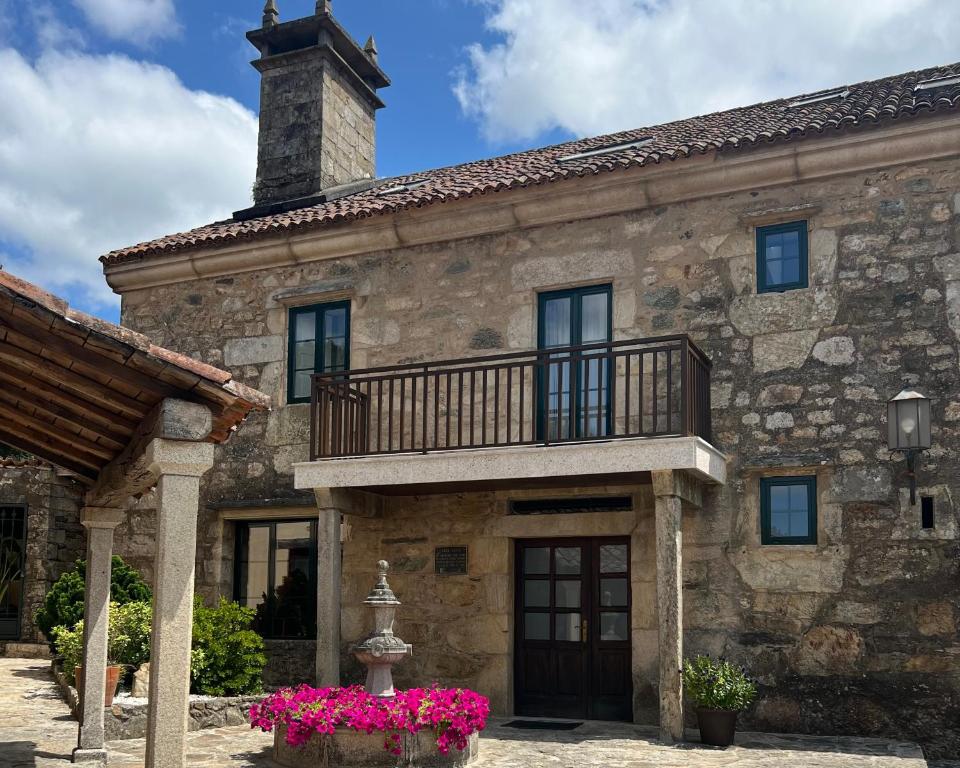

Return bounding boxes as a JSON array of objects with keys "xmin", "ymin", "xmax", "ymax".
[{"xmin": 294, "ymin": 336, "xmax": 726, "ymax": 743}]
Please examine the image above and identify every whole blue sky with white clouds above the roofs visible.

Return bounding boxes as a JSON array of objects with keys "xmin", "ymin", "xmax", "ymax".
[{"xmin": 0, "ymin": 0, "xmax": 960, "ymax": 320}]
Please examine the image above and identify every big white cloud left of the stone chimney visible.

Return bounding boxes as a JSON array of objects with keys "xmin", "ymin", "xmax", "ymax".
[{"xmin": 0, "ymin": 49, "xmax": 257, "ymax": 307}]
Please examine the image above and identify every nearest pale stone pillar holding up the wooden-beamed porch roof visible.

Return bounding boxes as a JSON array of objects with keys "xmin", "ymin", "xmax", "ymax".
[{"xmin": 146, "ymin": 438, "xmax": 213, "ymax": 768}]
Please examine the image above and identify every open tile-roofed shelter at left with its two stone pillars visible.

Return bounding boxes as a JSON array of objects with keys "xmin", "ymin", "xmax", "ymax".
[{"xmin": 0, "ymin": 271, "xmax": 269, "ymax": 768}]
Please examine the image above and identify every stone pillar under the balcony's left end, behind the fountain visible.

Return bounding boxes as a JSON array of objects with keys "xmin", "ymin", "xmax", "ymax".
[{"xmin": 316, "ymin": 489, "xmax": 343, "ymax": 688}]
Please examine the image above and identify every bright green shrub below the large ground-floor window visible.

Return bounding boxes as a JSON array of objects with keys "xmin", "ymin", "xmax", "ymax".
[{"xmin": 191, "ymin": 597, "xmax": 267, "ymax": 696}]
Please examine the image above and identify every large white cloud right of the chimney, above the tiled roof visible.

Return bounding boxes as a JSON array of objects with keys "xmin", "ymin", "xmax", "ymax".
[{"xmin": 455, "ymin": 0, "xmax": 960, "ymax": 142}]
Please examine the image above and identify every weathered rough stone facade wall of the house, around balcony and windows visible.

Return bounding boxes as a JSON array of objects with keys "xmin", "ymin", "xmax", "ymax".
[{"xmin": 123, "ymin": 154, "xmax": 960, "ymax": 754}]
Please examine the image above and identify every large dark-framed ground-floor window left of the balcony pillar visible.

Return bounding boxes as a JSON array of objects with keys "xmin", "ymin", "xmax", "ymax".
[{"xmin": 234, "ymin": 520, "xmax": 317, "ymax": 639}]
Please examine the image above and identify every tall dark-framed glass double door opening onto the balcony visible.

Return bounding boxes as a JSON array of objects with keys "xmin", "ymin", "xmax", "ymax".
[{"xmin": 537, "ymin": 285, "xmax": 613, "ymax": 440}]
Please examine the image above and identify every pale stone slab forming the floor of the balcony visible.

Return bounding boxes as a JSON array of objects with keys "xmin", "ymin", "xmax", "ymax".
[{"xmin": 294, "ymin": 437, "xmax": 726, "ymax": 490}]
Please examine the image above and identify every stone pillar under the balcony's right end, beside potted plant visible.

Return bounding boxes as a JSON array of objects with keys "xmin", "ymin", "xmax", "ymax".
[{"xmin": 652, "ymin": 471, "xmax": 683, "ymax": 744}]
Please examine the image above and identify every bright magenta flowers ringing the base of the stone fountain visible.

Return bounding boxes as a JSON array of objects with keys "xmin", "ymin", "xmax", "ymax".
[{"xmin": 250, "ymin": 685, "xmax": 490, "ymax": 763}]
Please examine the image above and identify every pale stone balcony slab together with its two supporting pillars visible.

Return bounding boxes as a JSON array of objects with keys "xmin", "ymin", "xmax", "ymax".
[{"xmin": 294, "ymin": 438, "xmax": 726, "ymax": 744}]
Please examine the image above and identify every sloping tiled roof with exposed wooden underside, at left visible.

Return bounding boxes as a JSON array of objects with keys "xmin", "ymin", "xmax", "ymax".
[{"xmin": 0, "ymin": 270, "xmax": 270, "ymax": 484}]
